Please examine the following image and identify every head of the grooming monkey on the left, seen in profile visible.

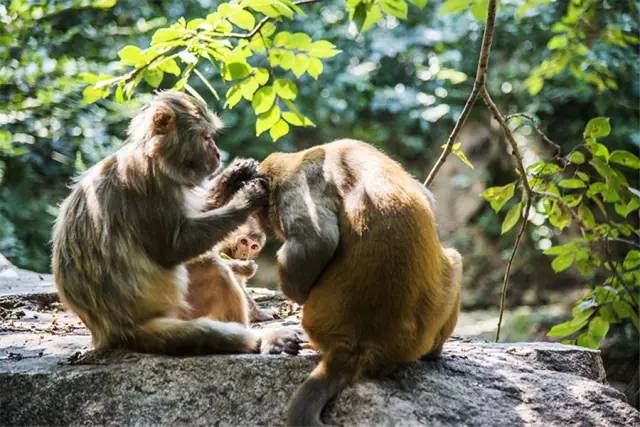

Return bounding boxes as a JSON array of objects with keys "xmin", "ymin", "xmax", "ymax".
[{"xmin": 129, "ymin": 91, "xmax": 223, "ymax": 186}]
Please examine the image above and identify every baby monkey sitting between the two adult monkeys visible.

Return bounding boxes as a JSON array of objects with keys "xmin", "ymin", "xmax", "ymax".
[{"xmin": 186, "ymin": 217, "xmax": 276, "ymax": 324}]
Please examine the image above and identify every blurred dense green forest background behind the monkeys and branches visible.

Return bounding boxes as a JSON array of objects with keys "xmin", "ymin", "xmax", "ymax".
[{"xmin": 0, "ymin": 0, "xmax": 640, "ymax": 404}]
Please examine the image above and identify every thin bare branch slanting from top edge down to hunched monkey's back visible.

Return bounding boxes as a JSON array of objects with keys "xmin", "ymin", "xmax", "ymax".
[{"xmin": 424, "ymin": 0, "xmax": 497, "ymax": 187}]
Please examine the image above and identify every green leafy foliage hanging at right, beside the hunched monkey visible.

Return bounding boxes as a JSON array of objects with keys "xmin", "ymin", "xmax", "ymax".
[{"xmin": 483, "ymin": 117, "xmax": 640, "ymax": 348}]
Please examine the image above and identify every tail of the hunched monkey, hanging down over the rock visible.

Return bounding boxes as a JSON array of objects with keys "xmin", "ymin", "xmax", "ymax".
[{"xmin": 287, "ymin": 356, "xmax": 354, "ymax": 426}]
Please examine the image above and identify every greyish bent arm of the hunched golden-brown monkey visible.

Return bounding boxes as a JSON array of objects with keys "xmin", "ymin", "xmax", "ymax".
[{"xmin": 277, "ymin": 186, "xmax": 340, "ymax": 304}]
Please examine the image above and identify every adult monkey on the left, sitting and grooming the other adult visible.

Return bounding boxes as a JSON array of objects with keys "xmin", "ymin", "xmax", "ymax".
[{"xmin": 53, "ymin": 92, "xmax": 298, "ymax": 354}]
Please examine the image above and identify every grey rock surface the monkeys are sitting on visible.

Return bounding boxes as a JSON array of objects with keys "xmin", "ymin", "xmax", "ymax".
[{"xmin": 0, "ymin": 270, "xmax": 640, "ymax": 426}]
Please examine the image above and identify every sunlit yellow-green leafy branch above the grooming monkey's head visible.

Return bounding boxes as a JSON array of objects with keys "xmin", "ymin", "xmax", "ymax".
[{"xmin": 83, "ymin": 0, "xmax": 348, "ymax": 141}]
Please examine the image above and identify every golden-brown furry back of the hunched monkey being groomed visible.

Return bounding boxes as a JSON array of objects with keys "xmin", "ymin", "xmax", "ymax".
[{"xmin": 296, "ymin": 140, "xmax": 454, "ymax": 376}]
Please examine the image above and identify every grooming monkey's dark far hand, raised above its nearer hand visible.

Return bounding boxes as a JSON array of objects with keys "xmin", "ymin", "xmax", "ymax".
[{"xmin": 205, "ymin": 159, "xmax": 259, "ymax": 210}]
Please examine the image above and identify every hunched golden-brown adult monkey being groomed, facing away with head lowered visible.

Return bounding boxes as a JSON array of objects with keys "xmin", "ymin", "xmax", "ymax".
[{"xmin": 259, "ymin": 140, "xmax": 462, "ymax": 425}]
